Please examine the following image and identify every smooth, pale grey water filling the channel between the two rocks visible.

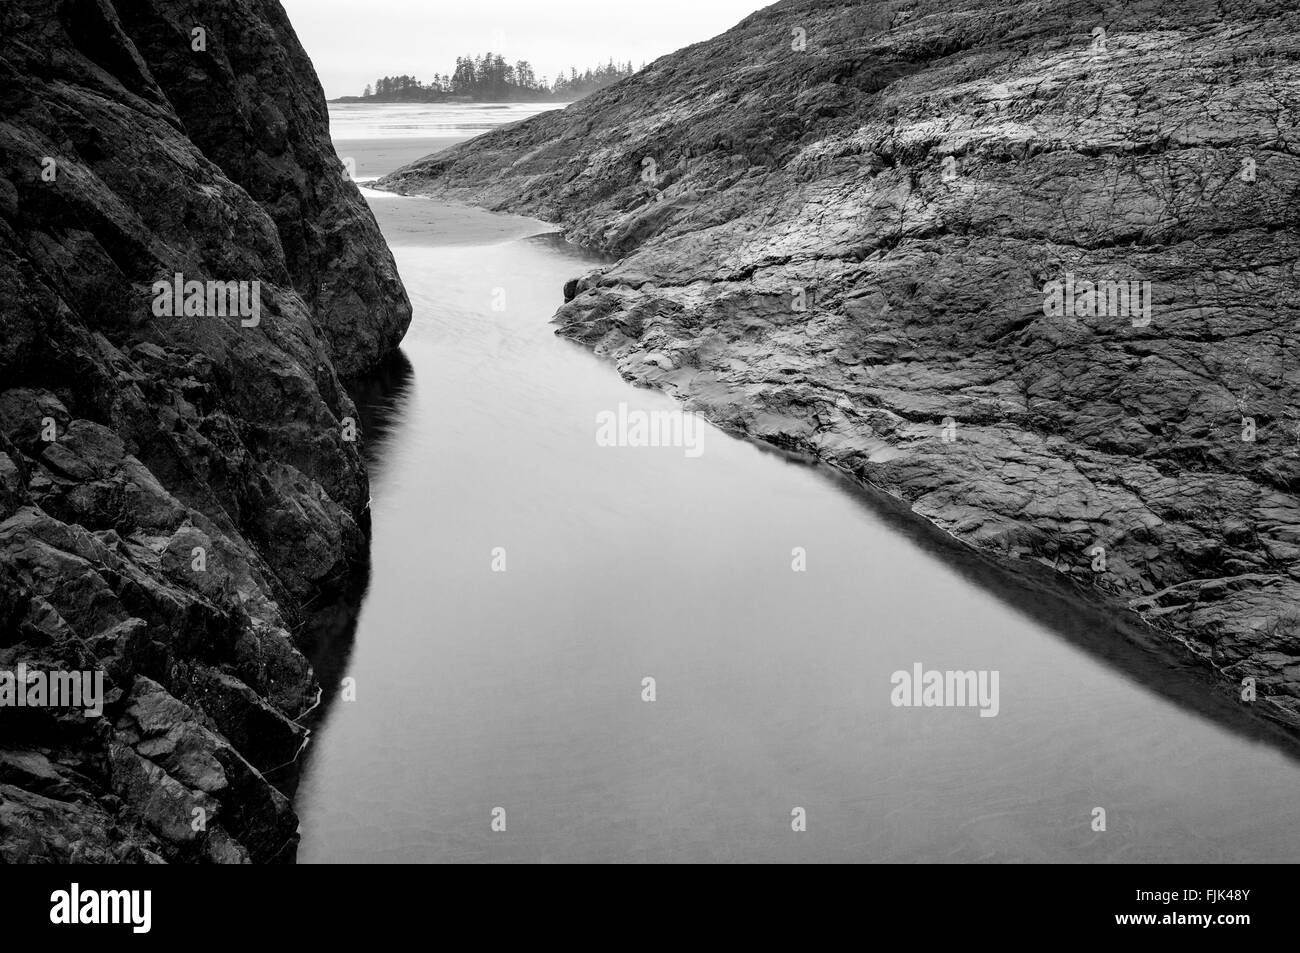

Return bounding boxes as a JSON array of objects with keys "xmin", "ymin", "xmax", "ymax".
[{"xmin": 296, "ymin": 109, "xmax": 1300, "ymax": 862}]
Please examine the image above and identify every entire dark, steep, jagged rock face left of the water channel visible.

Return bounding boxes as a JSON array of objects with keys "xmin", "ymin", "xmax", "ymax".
[{"xmin": 0, "ymin": 0, "xmax": 411, "ymax": 862}]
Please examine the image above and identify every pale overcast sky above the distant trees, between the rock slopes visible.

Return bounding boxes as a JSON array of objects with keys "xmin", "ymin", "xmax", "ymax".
[{"xmin": 281, "ymin": 0, "xmax": 774, "ymax": 99}]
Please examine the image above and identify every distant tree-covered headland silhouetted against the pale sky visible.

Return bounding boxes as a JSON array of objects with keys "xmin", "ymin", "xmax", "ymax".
[{"xmin": 334, "ymin": 52, "xmax": 644, "ymax": 103}]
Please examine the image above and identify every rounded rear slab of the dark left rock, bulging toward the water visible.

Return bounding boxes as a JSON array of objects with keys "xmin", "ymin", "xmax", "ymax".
[{"xmin": 111, "ymin": 0, "xmax": 411, "ymax": 376}]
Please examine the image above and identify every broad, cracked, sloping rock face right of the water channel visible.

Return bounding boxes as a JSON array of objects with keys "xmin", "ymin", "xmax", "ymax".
[{"xmin": 378, "ymin": 0, "xmax": 1300, "ymax": 725}]
